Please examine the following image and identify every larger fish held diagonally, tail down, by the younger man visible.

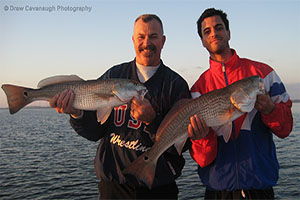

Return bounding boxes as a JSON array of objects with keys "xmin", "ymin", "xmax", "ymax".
[{"xmin": 123, "ymin": 76, "xmax": 264, "ymax": 188}]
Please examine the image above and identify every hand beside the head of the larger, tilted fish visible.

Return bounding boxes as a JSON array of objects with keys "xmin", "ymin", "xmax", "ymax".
[{"xmin": 254, "ymin": 93, "xmax": 275, "ymax": 115}]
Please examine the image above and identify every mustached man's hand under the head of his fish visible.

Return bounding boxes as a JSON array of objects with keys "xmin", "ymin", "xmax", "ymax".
[{"xmin": 130, "ymin": 97, "xmax": 156, "ymax": 125}]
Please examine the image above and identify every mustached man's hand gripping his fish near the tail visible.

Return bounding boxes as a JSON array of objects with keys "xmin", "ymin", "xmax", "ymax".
[{"xmin": 49, "ymin": 90, "xmax": 81, "ymax": 116}]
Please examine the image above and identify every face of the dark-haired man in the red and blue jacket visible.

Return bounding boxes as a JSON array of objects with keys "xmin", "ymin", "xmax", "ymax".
[{"xmin": 201, "ymin": 15, "xmax": 230, "ymax": 54}]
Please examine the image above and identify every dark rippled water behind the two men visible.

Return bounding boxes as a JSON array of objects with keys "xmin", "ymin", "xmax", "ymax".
[{"xmin": 0, "ymin": 103, "xmax": 300, "ymax": 200}]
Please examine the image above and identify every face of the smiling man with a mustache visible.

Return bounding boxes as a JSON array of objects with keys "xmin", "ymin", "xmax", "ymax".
[{"xmin": 132, "ymin": 19, "xmax": 166, "ymax": 66}]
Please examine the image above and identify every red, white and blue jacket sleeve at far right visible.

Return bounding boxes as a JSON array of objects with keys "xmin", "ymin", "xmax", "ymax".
[{"xmin": 261, "ymin": 71, "xmax": 293, "ymax": 138}]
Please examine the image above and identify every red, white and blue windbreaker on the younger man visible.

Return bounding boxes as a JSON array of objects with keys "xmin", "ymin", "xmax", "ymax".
[{"xmin": 190, "ymin": 50, "xmax": 293, "ymax": 191}]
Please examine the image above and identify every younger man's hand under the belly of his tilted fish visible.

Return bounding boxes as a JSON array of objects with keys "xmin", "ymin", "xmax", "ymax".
[{"xmin": 188, "ymin": 115, "xmax": 209, "ymax": 140}]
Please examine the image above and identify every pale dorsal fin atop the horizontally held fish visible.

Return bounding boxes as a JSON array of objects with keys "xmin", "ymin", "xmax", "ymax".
[{"xmin": 37, "ymin": 75, "xmax": 83, "ymax": 88}]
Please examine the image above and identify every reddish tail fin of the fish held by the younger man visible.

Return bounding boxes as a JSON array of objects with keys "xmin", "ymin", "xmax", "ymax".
[{"xmin": 122, "ymin": 152, "xmax": 157, "ymax": 189}]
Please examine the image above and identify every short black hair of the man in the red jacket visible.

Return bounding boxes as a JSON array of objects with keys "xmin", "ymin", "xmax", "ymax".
[{"xmin": 197, "ymin": 8, "xmax": 229, "ymax": 38}]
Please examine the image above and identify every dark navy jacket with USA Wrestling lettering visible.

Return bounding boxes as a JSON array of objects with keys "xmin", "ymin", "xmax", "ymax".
[{"xmin": 70, "ymin": 60, "xmax": 190, "ymax": 188}]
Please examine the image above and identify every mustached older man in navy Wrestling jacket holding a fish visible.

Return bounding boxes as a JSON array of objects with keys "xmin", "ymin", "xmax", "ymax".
[{"xmin": 50, "ymin": 14, "xmax": 190, "ymax": 199}]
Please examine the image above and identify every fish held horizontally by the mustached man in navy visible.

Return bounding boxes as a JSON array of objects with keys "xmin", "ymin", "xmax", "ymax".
[{"xmin": 2, "ymin": 76, "xmax": 147, "ymax": 123}]
